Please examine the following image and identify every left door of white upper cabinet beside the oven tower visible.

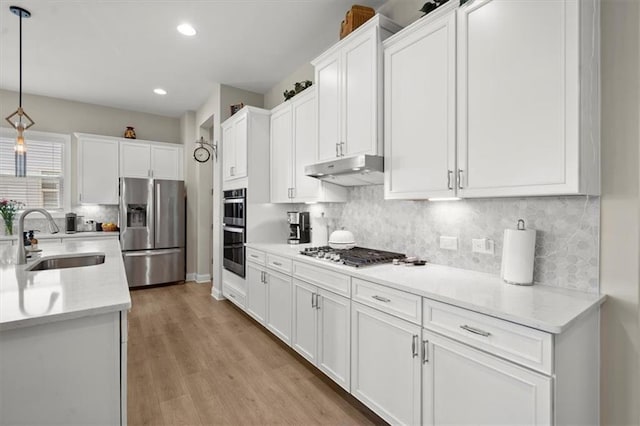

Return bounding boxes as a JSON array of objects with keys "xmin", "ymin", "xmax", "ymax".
[{"xmin": 270, "ymin": 104, "xmax": 293, "ymax": 203}]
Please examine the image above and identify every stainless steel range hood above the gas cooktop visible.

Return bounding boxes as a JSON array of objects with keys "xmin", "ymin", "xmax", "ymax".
[{"xmin": 304, "ymin": 155, "xmax": 384, "ymax": 186}]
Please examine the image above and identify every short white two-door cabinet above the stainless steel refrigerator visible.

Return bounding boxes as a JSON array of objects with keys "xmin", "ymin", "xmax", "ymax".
[{"xmin": 120, "ymin": 141, "xmax": 184, "ymax": 180}]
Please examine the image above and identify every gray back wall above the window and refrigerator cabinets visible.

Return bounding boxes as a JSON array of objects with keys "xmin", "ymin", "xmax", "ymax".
[{"xmin": 0, "ymin": 89, "xmax": 180, "ymax": 143}]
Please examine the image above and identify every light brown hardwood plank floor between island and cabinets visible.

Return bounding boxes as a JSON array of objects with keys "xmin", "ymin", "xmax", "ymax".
[{"xmin": 127, "ymin": 283, "xmax": 384, "ymax": 425}]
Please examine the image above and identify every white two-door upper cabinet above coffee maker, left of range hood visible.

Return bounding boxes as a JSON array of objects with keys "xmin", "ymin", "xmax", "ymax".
[{"xmin": 271, "ymin": 87, "xmax": 347, "ymax": 203}]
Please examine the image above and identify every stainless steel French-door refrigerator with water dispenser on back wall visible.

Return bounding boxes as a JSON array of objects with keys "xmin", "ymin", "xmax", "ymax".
[{"xmin": 120, "ymin": 178, "xmax": 186, "ymax": 287}]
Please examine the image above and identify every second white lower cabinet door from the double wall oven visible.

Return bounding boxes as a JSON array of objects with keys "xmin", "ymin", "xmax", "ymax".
[{"xmin": 266, "ymin": 271, "xmax": 292, "ymax": 344}]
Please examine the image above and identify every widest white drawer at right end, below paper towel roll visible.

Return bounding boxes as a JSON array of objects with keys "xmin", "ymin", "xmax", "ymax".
[{"xmin": 423, "ymin": 298, "xmax": 553, "ymax": 374}]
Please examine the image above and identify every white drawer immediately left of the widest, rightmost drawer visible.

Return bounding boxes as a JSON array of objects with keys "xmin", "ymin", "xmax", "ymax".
[{"xmin": 352, "ymin": 278, "xmax": 422, "ymax": 325}]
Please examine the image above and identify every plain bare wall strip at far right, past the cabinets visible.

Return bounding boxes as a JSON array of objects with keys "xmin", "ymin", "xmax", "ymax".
[{"xmin": 600, "ymin": 0, "xmax": 640, "ymax": 425}]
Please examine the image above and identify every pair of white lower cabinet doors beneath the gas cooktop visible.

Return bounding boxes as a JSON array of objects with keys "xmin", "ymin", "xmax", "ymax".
[{"xmin": 291, "ymin": 278, "xmax": 351, "ymax": 391}]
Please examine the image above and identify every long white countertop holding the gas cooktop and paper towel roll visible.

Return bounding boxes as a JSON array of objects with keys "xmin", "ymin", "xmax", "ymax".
[{"xmin": 247, "ymin": 243, "xmax": 606, "ymax": 334}]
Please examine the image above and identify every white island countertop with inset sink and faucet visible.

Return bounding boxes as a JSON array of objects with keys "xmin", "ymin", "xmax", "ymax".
[{"xmin": 0, "ymin": 239, "xmax": 131, "ymax": 331}]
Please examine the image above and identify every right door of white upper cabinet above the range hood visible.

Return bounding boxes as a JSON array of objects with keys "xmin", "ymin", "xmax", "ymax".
[{"xmin": 339, "ymin": 31, "xmax": 378, "ymax": 155}]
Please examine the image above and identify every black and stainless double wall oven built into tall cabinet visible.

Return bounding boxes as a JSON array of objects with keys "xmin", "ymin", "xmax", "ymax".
[{"xmin": 222, "ymin": 188, "xmax": 247, "ymax": 278}]
